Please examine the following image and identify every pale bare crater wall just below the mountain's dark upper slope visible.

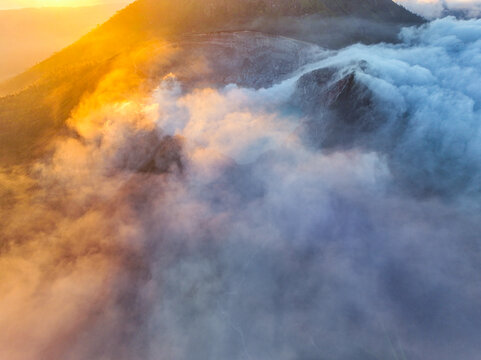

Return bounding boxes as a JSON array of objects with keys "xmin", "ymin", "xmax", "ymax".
[{"xmin": 170, "ymin": 31, "xmax": 320, "ymax": 89}]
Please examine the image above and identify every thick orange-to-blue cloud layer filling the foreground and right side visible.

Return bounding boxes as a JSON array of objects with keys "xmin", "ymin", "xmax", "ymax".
[{"xmin": 0, "ymin": 19, "xmax": 481, "ymax": 360}]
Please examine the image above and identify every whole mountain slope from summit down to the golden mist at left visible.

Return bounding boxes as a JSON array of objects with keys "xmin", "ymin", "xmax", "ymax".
[{"xmin": 0, "ymin": 0, "xmax": 422, "ymax": 162}]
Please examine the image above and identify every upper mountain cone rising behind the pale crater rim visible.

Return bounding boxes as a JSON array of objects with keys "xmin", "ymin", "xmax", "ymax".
[{"xmin": 0, "ymin": 0, "xmax": 422, "ymax": 95}]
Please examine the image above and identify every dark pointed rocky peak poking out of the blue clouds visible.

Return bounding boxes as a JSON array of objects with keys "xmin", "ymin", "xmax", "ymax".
[{"xmin": 292, "ymin": 64, "xmax": 385, "ymax": 148}]
